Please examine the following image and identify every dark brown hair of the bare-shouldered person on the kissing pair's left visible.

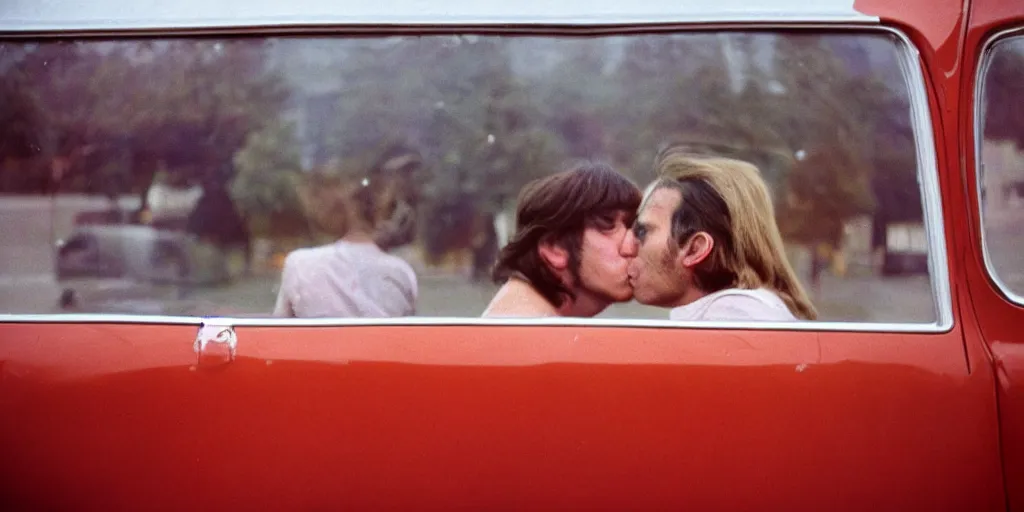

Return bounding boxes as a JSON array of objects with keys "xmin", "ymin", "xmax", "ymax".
[{"xmin": 492, "ymin": 162, "xmax": 641, "ymax": 307}]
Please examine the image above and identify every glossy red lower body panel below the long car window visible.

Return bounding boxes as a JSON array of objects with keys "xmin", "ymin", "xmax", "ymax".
[{"xmin": 0, "ymin": 319, "xmax": 1002, "ymax": 510}]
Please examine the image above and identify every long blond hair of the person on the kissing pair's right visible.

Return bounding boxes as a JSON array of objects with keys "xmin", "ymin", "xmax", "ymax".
[{"xmin": 652, "ymin": 151, "xmax": 817, "ymax": 319}]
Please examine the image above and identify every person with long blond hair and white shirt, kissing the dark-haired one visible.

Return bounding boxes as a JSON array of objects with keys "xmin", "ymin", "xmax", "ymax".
[{"xmin": 623, "ymin": 151, "xmax": 817, "ymax": 321}]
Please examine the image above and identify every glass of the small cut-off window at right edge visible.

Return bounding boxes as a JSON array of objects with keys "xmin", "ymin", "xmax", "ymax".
[{"xmin": 978, "ymin": 36, "xmax": 1024, "ymax": 296}]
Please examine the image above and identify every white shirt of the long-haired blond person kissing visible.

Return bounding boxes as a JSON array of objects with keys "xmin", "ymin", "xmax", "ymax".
[{"xmin": 669, "ymin": 288, "xmax": 797, "ymax": 322}]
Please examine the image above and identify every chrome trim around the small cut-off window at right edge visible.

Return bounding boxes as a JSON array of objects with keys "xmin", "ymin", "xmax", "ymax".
[{"xmin": 972, "ymin": 27, "xmax": 1024, "ymax": 306}]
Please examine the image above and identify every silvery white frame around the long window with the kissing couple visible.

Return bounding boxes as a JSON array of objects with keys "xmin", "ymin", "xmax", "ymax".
[{"xmin": 0, "ymin": 22, "xmax": 954, "ymax": 333}]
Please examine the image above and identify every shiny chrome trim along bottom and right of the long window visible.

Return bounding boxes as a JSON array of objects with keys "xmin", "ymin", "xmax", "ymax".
[{"xmin": 0, "ymin": 24, "xmax": 953, "ymax": 333}]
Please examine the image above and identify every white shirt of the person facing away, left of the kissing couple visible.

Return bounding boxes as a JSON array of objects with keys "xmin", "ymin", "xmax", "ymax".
[{"xmin": 273, "ymin": 241, "xmax": 418, "ymax": 317}]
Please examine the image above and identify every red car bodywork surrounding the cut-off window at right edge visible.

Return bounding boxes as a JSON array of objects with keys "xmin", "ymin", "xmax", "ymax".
[{"xmin": 961, "ymin": 0, "xmax": 1024, "ymax": 510}]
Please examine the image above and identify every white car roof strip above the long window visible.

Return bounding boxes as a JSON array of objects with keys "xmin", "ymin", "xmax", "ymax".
[{"xmin": 0, "ymin": 0, "xmax": 878, "ymax": 33}]
